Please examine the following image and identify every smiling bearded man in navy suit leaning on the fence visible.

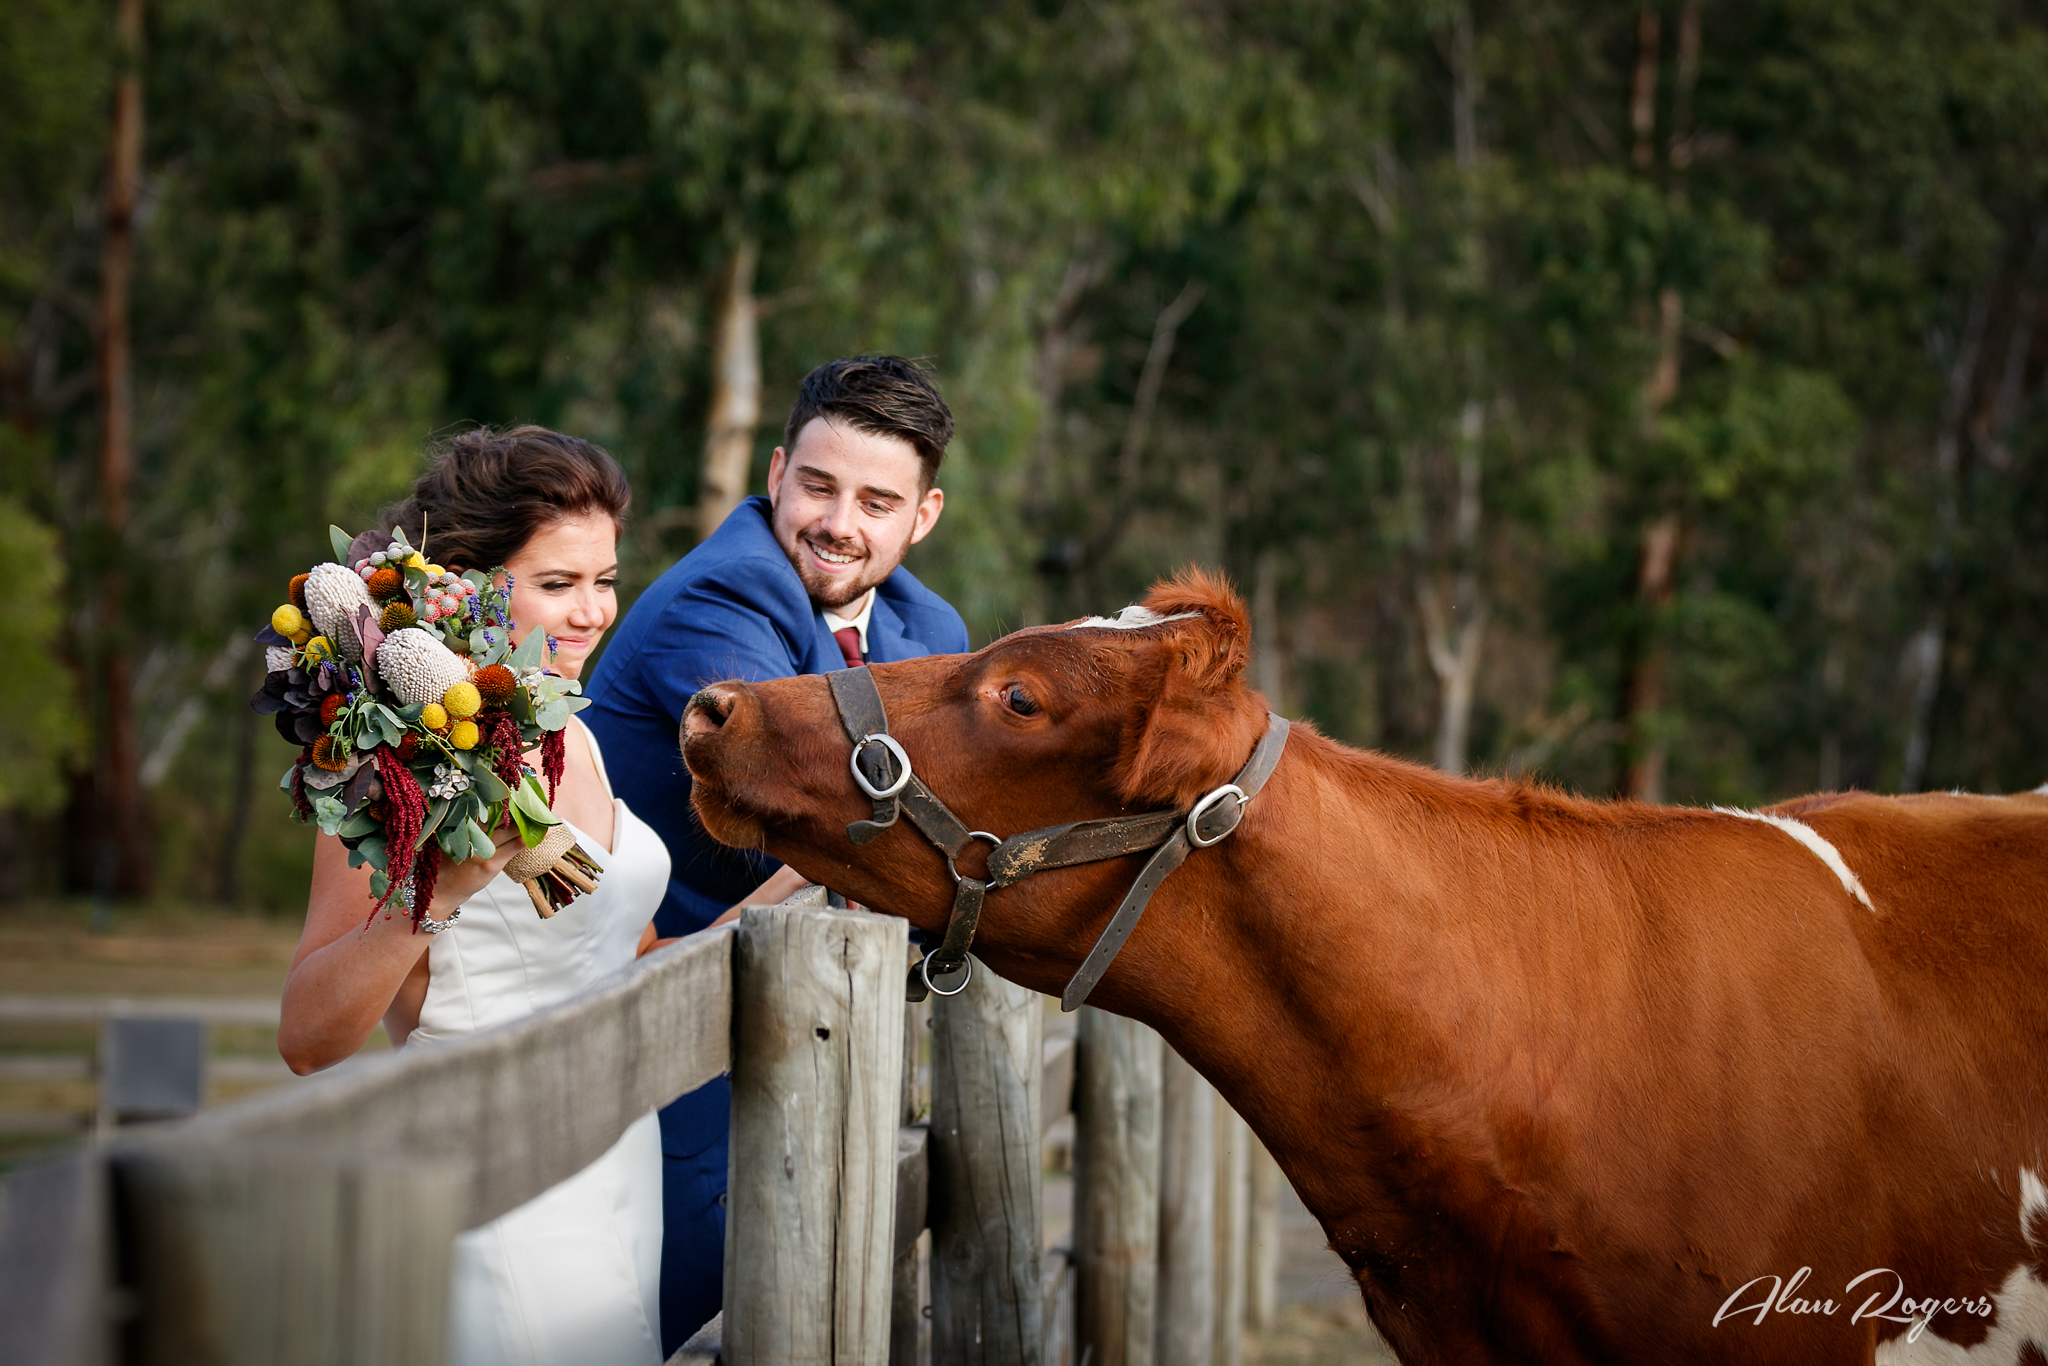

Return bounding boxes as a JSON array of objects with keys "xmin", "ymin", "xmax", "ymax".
[{"xmin": 584, "ymin": 356, "xmax": 967, "ymax": 1354}]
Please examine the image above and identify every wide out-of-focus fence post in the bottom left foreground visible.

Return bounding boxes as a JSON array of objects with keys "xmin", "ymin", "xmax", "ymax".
[{"xmin": 113, "ymin": 1143, "xmax": 471, "ymax": 1366}]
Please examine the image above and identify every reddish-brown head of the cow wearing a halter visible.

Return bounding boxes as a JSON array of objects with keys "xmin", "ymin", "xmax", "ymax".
[{"xmin": 682, "ymin": 571, "xmax": 1266, "ymax": 993}]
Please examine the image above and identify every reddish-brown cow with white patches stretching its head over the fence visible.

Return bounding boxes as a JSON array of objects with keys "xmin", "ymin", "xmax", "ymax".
[{"xmin": 684, "ymin": 575, "xmax": 2048, "ymax": 1366}]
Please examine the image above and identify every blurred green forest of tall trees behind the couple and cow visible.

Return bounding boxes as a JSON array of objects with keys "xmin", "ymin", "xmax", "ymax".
[{"xmin": 0, "ymin": 0, "xmax": 2048, "ymax": 911}]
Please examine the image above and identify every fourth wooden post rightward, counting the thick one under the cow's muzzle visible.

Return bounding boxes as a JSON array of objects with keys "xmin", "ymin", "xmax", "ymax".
[{"xmin": 1159, "ymin": 1049, "xmax": 1217, "ymax": 1366}]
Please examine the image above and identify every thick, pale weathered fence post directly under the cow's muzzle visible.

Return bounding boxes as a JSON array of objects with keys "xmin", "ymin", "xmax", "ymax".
[{"xmin": 723, "ymin": 907, "xmax": 909, "ymax": 1366}]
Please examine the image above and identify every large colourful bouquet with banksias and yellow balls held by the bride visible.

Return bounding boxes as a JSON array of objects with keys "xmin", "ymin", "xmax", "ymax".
[{"xmin": 252, "ymin": 526, "xmax": 598, "ymax": 928}]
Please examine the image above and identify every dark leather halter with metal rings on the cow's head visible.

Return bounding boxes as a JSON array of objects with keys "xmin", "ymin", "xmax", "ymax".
[{"xmin": 825, "ymin": 668, "xmax": 1286, "ymax": 1010}]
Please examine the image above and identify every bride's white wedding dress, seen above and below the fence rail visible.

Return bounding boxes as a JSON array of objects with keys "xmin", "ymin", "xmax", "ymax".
[{"xmin": 408, "ymin": 723, "xmax": 668, "ymax": 1366}]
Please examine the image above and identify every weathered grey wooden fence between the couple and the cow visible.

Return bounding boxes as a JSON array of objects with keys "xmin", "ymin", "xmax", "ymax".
[{"xmin": 0, "ymin": 889, "xmax": 1274, "ymax": 1366}]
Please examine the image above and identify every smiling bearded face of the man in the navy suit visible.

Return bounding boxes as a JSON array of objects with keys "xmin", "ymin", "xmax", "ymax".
[{"xmin": 768, "ymin": 416, "xmax": 946, "ymax": 610}]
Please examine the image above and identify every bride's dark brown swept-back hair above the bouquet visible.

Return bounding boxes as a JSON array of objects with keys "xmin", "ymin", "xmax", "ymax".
[{"xmin": 379, "ymin": 426, "xmax": 633, "ymax": 569}]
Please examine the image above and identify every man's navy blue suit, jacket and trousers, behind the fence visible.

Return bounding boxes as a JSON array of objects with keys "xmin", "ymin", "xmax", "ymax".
[{"xmin": 582, "ymin": 496, "xmax": 967, "ymax": 1356}]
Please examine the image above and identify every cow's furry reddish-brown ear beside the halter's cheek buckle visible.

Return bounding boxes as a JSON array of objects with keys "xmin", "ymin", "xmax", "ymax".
[{"xmin": 1114, "ymin": 571, "xmax": 1266, "ymax": 807}]
